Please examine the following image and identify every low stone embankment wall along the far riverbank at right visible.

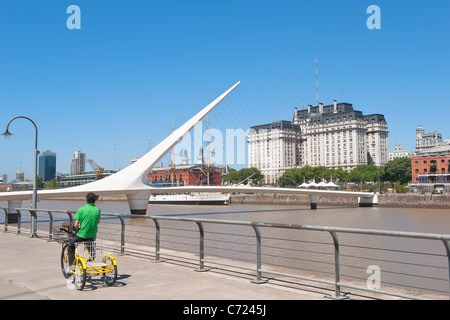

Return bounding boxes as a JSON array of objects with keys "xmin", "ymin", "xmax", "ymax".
[{"xmin": 231, "ymin": 193, "xmax": 450, "ymax": 209}]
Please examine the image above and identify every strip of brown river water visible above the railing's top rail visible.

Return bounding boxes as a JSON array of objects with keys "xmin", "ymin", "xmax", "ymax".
[{"xmin": 13, "ymin": 200, "xmax": 450, "ymax": 234}]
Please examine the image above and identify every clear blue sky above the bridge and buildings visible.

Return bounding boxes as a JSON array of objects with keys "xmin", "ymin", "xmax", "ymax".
[{"xmin": 0, "ymin": 0, "xmax": 450, "ymax": 179}]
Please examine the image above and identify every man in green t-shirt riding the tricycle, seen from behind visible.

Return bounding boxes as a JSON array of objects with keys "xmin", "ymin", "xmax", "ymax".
[{"xmin": 67, "ymin": 192, "xmax": 100, "ymax": 265}]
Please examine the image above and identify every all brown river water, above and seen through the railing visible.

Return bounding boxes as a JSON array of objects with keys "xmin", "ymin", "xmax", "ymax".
[{"xmin": 0, "ymin": 200, "xmax": 450, "ymax": 295}]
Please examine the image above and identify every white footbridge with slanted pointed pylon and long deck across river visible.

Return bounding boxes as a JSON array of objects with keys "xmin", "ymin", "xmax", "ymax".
[{"xmin": 0, "ymin": 81, "xmax": 376, "ymax": 215}]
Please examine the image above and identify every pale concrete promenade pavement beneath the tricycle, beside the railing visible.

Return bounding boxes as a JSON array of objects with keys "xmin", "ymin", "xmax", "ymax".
[{"xmin": 0, "ymin": 232, "xmax": 323, "ymax": 300}]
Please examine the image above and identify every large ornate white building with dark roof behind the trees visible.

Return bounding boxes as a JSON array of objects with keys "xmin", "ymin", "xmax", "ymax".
[{"xmin": 248, "ymin": 100, "xmax": 389, "ymax": 183}]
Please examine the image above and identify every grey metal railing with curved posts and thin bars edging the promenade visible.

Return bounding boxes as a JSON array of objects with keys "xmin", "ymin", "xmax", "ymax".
[{"xmin": 0, "ymin": 207, "xmax": 450, "ymax": 299}]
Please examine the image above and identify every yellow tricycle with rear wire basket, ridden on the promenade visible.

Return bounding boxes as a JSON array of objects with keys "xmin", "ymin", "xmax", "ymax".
[{"xmin": 61, "ymin": 230, "xmax": 117, "ymax": 290}]
